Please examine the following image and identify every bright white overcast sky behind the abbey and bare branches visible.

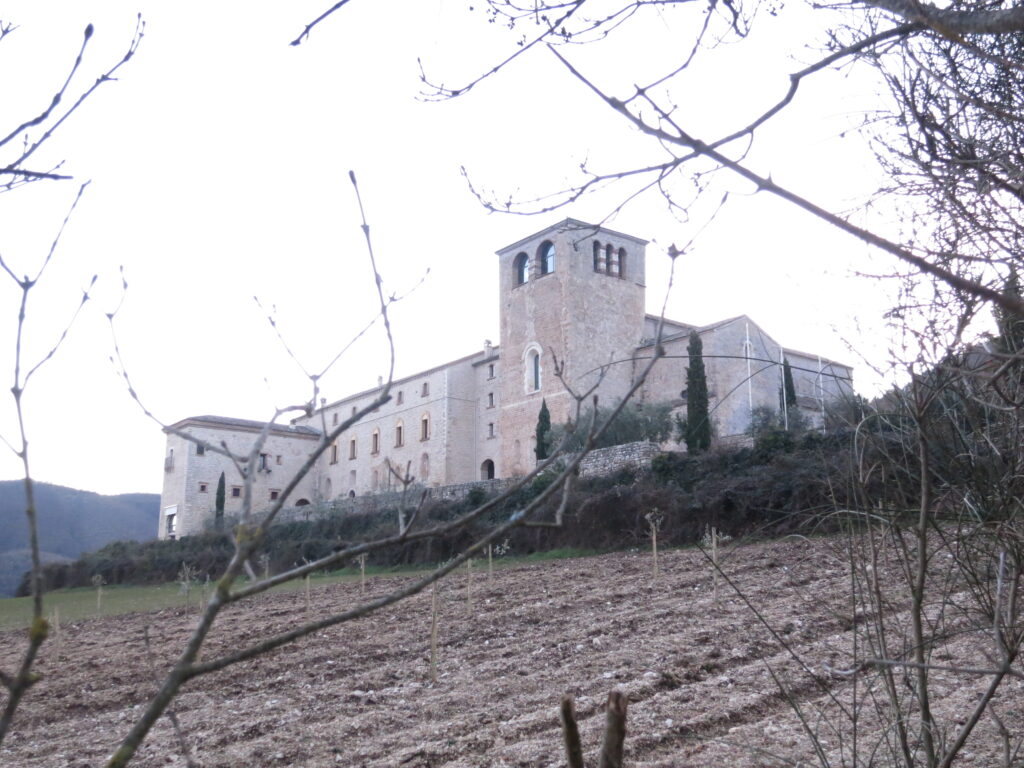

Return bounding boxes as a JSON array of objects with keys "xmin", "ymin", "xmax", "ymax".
[{"xmin": 0, "ymin": 0, "xmax": 913, "ymax": 494}]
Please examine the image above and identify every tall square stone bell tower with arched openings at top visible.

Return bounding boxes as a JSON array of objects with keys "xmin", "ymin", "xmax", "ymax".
[{"xmin": 498, "ymin": 219, "xmax": 647, "ymax": 475}]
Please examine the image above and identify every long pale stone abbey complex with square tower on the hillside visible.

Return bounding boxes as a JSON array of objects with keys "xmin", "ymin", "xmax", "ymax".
[{"xmin": 160, "ymin": 219, "xmax": 852, "ymax": 538}]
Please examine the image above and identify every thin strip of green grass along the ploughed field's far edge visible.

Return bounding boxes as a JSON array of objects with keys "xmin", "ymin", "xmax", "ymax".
[{"xmin": 0, "ymin": 547, "xmax": 600, "ymax": 630}]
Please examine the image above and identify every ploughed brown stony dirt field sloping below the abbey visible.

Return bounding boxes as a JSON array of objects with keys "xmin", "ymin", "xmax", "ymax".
[{"xmin": 0, "ymin": 539, "xmax": 1024, "ymax": 768}]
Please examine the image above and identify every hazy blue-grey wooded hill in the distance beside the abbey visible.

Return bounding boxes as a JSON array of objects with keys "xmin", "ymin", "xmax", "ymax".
[{"xmin": 0, "ymin": 480, "xmax": 160, "ymax": 596}]
